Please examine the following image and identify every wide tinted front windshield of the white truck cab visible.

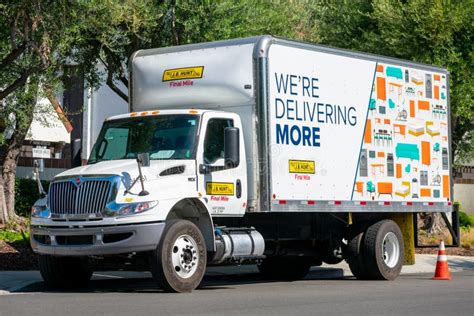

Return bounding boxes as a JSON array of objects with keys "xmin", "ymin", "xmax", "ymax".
[{"xmin": 89, "ymin": 114, "xmax": 199, "ymax": 163}]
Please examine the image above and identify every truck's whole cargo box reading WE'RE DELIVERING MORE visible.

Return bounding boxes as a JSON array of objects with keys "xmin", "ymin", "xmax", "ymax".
[{"xmin": 130, "ymin": 36, "xmax": 452, "ymax": 212}]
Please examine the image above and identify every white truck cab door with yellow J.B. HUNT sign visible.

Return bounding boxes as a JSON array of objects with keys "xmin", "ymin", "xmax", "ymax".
[{"xmin": 196, "ymin": 112, "xmax": 247, "ymax": 216}]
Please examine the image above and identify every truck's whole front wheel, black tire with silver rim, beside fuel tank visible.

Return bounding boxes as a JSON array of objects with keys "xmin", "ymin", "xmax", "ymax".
[{"xmin": 151, "ymin": 220, "xmax": 207, "ymax": 293}]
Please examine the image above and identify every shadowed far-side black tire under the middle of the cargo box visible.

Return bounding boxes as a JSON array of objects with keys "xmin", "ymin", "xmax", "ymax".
[{"xmin": 258, "ymin": 256, "xmax": 311, "ymax": 281}]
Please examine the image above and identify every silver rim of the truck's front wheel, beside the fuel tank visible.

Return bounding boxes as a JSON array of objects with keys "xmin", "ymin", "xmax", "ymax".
[{"xmin": 171, "ymin": 235, "xmax": 199, "ymax": 279}]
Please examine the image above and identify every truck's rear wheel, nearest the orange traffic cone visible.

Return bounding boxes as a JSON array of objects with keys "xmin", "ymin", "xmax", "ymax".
[{"xmin": 362, "ymin": 220, "xmax": 404, "ymax": 280}]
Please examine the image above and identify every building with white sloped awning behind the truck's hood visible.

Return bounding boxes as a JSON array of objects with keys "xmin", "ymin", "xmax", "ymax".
[{"xmin": 17, "ymin": 65, "xmax": 128, "ymax": 180}]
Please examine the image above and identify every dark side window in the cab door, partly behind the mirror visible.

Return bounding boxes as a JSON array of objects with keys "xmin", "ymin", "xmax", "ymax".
[{"xmin": 204, "ymin": 119, "xmax": 234, "ymax": 164}]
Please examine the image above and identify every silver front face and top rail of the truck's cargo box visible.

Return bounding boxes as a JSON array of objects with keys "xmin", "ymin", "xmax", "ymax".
[{"xmin": 129, "ymin": 35, "xmax": 448, "ymax": 111}]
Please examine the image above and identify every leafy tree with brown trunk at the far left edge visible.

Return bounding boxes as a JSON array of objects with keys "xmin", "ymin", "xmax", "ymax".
[{"xmin": 0, "ymin": 0, "xmax": 80, "ymax": 223}]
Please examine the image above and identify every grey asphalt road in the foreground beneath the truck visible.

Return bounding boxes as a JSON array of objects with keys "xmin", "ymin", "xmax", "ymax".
[{"xmin": 0, "ymin": 271, "xmax": 474, "ymax": 316}]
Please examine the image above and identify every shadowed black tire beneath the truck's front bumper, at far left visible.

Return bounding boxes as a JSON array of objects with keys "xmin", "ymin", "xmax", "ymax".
[{"xmin": 39, "ymin": 255, "xmax": 92, "ymax": 288}]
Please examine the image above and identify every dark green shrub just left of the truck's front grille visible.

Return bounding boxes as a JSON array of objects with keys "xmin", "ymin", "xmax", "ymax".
[{"xmin": 15, "ymin": 178, "xmax": 49, "ymax": 217}]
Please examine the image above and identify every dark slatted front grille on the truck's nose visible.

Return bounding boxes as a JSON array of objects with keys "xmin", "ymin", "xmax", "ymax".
[{"xmin": 48, "ymin": 179, "xmax": 112, "ymax": 215}]
